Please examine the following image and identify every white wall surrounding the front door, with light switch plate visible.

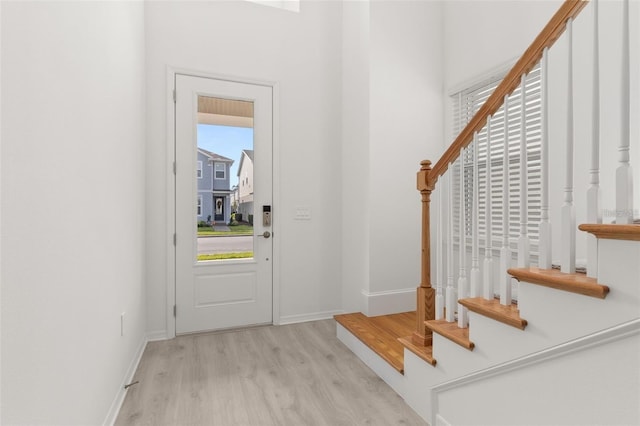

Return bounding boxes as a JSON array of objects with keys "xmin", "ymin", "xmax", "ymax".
[{"xmin": 146, "ymin": 2, "xmax": 344, "ymax": 335}]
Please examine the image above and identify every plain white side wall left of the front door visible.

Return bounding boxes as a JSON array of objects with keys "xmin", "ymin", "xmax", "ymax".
[{"xmin": 0, "ymin": 2, "xmax": 145, "ymax": 424}]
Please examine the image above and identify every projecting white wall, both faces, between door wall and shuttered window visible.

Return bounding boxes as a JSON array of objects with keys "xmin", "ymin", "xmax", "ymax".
[{"xmin": 342, "ymin": 1, "xmax": 442, "ymax": 315}]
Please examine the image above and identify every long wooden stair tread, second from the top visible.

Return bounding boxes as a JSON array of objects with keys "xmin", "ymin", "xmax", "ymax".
[{"xmin": 507, "ymin": 268, "xmax": 609, "ymax": 299}]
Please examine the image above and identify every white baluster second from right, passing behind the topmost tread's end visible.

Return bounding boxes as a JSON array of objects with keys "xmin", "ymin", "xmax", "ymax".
[{"xmin": 586, "ymin": 0, "xmax": 602, "ymax": 278}]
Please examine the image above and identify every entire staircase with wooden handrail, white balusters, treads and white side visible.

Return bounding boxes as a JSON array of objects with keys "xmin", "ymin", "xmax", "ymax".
[{"xmin": 336, "ymin": 0, "xmax": 640, "ymax": 425}]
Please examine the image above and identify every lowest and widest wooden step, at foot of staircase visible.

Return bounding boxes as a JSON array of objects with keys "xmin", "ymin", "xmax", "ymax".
[{"xmin": 333, "ymin": 312, "xmax": 404, "ymax": 374}]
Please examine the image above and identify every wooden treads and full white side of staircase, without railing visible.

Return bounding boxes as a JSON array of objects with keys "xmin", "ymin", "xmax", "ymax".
[{"xmin": 404, "ymin": 225, "xmax": 640, "ymax": 425}]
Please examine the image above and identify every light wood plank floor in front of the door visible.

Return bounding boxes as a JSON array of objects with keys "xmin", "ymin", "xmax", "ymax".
[{"xmin": 116, "ymin": 320, "xmax": 426, "ymax": 426}]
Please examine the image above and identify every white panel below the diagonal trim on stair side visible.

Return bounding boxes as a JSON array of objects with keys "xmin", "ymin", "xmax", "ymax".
[{"xmin": 428, "ymin": 319, "xmax": 640, "ymax": 425}]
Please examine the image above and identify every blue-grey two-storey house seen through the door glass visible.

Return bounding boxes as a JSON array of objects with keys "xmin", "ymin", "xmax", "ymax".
[{"xmin": 197, "ymin": 148, "xmax": 233, "ymax": 223}]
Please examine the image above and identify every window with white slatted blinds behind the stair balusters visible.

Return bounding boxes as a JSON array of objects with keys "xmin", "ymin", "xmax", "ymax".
[{"xmin": 451, "ymin": 66, "xmax": 541, "ymax": 253}]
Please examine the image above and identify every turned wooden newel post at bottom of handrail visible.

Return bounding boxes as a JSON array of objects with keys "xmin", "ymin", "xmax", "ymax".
[{"xmin": 412, "ymin": 160, "xmax": 436, "ymax": 346}]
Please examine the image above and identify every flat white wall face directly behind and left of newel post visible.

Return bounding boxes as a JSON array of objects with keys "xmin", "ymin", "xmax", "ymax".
[{"xmin": 369, "ymin": 1, "xmax": 443, "ymax": 309}]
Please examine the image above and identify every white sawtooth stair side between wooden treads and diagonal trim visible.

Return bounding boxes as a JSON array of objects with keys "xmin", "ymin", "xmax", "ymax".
[{"xmin": 404, "ymin": 235, "xmax": 640, "ymax": 424}]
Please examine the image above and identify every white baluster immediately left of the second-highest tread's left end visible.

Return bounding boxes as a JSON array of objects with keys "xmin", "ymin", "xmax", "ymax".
[{"xmin": 500, "ymin": 96, "xmax": 511, "ymax": 305}]
